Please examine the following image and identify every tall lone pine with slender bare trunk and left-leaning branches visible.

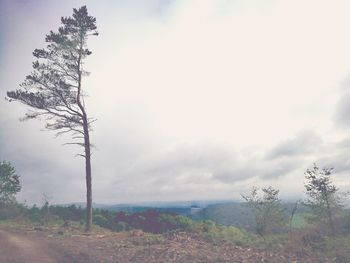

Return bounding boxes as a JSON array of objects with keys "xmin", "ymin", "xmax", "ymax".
[{"xmin": 7, "ymin": 6, "xmax": 98, "ymax": 231}]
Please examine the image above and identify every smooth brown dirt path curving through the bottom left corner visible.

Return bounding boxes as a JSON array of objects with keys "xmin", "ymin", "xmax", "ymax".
[{"xmin": 0, "ymin": 230, "xmax": 56, "ymax": 263}]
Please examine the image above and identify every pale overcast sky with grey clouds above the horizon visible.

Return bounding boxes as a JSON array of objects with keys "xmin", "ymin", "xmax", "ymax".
[{"xmin": 0, "ymin": 0, "xmax": 350, "ymax": 204}]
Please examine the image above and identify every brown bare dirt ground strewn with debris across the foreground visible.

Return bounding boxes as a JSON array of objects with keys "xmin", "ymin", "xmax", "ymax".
[{"xmin": 0, "ymin": 227, "xmax": 332, "ymax": 263}]
